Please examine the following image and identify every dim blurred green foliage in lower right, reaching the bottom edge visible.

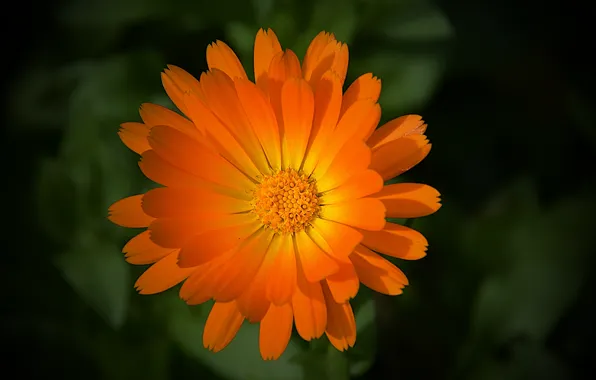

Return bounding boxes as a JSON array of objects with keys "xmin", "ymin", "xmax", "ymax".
[{"xmin": 459, "ymin": 188, "xmax": 596, "ymax": 379}]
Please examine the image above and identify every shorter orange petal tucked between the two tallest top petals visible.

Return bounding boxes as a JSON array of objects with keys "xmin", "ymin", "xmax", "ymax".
[{"xmin": 267, "ymin": 49, "xmax": 302, "ymax": 131}]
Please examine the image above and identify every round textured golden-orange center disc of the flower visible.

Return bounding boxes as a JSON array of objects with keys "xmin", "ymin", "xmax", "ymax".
[{"xmin": 253, "ymin": 169, "xmax": 319, "ymax": 233}]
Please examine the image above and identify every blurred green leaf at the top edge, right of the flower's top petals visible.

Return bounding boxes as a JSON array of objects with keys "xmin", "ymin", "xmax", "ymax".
[{"xmin": 350, "ymin": 0, "xmax": 452, "ymax": 116}]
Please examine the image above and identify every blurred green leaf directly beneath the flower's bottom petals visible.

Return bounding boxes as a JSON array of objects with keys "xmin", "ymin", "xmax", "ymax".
[{"xmin": 170, "ymin": 301, "xmax": 303, "ymax": 380}]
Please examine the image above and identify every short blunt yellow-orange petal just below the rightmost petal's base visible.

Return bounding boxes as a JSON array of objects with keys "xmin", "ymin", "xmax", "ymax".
[{"xmin": 321, "ymin": 198, "xmax": 385, "ymax": 231}]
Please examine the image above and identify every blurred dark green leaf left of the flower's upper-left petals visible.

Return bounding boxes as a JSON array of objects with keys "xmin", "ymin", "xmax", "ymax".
[{"xmin": 60, "ymin": 53, "xmax": 163, "ymax": 233}]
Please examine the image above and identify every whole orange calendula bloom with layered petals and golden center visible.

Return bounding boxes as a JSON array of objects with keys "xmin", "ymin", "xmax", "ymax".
[{"xmin": 109, "ymin": 30, "xmax": 440, "ymax": 359}]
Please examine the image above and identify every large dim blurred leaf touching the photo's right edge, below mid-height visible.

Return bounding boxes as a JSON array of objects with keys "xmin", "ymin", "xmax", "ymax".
[{"xmin": 473, "ymin": 193, "xmax": 596, "ymax": 343}]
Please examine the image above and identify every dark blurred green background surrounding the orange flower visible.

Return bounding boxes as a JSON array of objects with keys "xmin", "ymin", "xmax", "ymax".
[{"xmin": 5, "ymin": 0, "xmax": 596, "ymax": 380}]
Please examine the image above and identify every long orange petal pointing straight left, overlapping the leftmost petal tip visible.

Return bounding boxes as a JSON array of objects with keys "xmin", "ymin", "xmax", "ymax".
[{"xmin": 143, "ymin": 187, "xmax": 252, "ymax": 218}]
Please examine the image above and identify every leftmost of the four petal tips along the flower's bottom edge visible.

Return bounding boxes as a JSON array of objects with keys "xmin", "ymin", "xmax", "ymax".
[{"xmin": 203, "ymin": 301, "xmax": 244, "ymax": 352}]
